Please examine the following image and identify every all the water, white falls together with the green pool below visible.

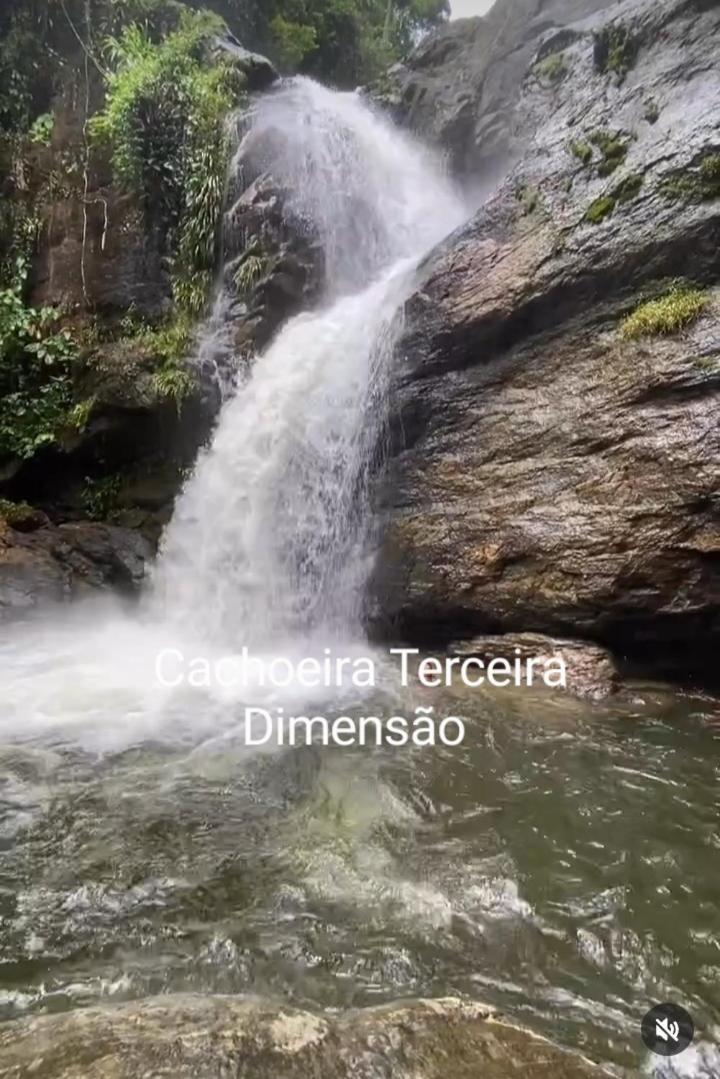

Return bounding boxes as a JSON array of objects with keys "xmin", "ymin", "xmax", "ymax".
[{"xmin": 0, "ymin": 80, "xmax": 720, "ymax": 1076}]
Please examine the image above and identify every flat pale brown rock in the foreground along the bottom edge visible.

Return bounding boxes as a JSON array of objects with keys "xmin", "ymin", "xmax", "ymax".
[{"xmin": 0, "ymin": 996, "xmax": 608, "ymax": 1079}]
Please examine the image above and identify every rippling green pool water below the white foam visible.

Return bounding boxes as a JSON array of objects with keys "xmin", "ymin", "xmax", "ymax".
[{"xmin": 0, "ymin": 673, "xmax": 720, "ymax": 1075}]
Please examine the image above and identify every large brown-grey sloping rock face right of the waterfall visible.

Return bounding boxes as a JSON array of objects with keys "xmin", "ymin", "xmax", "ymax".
[{"xmin": 376, "ymin": 0, "xmax": 720, "ymax": 674}]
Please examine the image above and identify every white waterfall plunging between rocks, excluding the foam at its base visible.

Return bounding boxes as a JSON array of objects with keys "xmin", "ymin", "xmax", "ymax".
[{"xmin": 154, "ymin": 79, "xmax": 463, "ymax": 646}]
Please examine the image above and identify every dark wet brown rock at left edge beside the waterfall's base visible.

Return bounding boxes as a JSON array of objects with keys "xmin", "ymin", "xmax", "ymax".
[{"xmin": 0, "ymin": 519, "xmax": 151, "ymax": 620}]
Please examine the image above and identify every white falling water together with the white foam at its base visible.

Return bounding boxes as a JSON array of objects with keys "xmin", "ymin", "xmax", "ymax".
[{"xmin": 0, "ymin": 79, "xmax": 464, "ymax": 748}]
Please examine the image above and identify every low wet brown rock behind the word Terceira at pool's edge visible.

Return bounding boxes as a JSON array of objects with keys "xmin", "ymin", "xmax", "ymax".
[{"xmin": 449, "ymin": 633, "xmax": 620, "ymax": 700}]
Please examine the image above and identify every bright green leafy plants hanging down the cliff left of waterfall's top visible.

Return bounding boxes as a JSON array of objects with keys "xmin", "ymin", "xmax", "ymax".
[{"xmin": 92, "ymin": 12, "xmax": 240, "ymax": 315}]
